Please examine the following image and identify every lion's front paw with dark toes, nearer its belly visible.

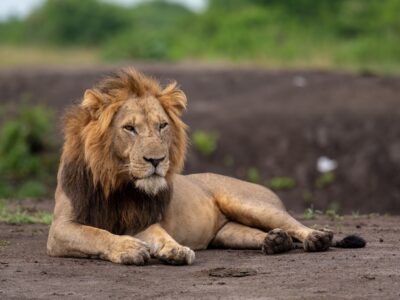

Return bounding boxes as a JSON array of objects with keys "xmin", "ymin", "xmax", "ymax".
[{"xmin": 157, "ymin": 244, "xmax": 195, "ymax": 265}]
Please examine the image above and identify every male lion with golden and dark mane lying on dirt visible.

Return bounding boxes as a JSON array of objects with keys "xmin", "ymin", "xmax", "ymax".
[{"xmin": 47, "ymin": 69, "xmax": 364, "ymax": 265}]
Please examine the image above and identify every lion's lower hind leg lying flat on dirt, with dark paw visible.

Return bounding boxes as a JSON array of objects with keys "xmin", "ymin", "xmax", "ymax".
[{"xmin": 210, "ymin": 222, "xmax": 293, "ymax": 254}]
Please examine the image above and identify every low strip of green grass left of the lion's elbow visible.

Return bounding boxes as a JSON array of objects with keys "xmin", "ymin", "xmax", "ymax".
[{"xmin": 0, "ymin": 201, "xmax": 53, "ymax": 225}]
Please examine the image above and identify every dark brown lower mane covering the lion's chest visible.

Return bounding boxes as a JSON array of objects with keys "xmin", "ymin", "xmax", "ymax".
[{"xmin": 61, "ymin": 158, "xmax": 172, "ymax": 234}]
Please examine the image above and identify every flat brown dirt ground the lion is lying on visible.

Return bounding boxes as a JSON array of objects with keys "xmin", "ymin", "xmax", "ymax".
[{"xmin": 0, "ymin": 200, "xmax": 400, "ymax": 299}]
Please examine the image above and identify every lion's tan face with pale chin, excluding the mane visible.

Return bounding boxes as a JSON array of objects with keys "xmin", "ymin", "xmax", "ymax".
[{"xmin": 111, "ymin": 95, "xmax": 172, "ymax": 194}]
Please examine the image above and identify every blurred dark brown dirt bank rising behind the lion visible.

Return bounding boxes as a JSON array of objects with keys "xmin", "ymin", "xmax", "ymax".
[{"xmin": 0, "ymin": 64, "xmax": 400, "ymax": 213}]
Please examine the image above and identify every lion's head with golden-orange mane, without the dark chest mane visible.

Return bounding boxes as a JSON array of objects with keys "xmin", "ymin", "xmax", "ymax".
[{"xmin": 62, "ymin": 69, "xmax": 187, "ymax": 196}]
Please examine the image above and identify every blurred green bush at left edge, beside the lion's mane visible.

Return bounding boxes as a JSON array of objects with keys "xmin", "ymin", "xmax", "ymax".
[{"xmin": 0, "ymin": 104, "xmax": 58, "ymax": 198}]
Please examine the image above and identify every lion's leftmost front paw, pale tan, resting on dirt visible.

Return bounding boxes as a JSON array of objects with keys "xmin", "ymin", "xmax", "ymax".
[{"xmin": 105, "ymin": 236, "xmax": 150, "ymax": 265}]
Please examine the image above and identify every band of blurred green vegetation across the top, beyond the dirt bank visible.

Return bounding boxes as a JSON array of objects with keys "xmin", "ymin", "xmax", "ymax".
[{"xmin": 0, "ymin": 0, "xmax": 400, "ymax": 72}]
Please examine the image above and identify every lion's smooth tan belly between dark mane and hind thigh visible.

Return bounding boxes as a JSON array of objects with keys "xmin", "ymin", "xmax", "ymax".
[{"xmin": 162, "ymin": 175, "xmax": 226, "ymax": 249}]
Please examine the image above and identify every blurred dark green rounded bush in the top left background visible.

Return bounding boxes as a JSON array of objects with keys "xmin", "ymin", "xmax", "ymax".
[{"xmin": 0, "ymin": 0, "xmax": 129, "ymax": 46}]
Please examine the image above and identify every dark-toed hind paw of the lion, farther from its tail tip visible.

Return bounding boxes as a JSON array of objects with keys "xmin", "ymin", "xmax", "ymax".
[{"xmin": 261, "ymin": 228, "xmax": 293, "ymax": 254}]
